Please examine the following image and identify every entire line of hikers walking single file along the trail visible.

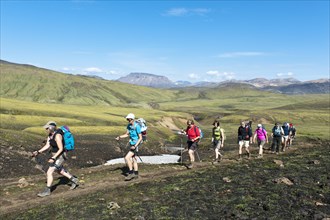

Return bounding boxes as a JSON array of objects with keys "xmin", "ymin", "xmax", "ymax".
[{"xmin": 32, "ymin": 113, "xmax": 296, "ymax": 197}]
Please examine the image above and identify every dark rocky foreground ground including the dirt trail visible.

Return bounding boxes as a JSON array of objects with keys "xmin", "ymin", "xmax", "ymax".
[{"xmin": 0, "ymin": 137, "xmax": 330, "ymax": 219}]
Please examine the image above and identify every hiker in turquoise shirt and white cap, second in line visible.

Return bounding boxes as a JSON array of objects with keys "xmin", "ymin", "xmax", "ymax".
[{"xmin": 116, "ymin": 113, "xmax": 142, "ymax": 181}]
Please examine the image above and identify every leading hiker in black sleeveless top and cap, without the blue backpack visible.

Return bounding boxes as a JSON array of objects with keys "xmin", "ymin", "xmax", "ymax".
[{"xmin": 32, "ymin": 121, "xmax": 79, "ymax": 197}]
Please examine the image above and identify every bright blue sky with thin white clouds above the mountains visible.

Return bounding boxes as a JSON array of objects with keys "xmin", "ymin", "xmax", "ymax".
[{"xmin": 1, "ymin": 0, "xmax": 330, "ymax": 82}]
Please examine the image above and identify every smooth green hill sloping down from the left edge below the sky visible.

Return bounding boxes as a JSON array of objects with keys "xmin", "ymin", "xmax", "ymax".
[{"xmin": 0, "ymin": 61, "xmax": 179, "ymax": 105}]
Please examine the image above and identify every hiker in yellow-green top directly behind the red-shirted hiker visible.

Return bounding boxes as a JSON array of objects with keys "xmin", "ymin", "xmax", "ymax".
[{"xmin": 212, "ymin": 120, "xmax": 225, "ymax": 163}]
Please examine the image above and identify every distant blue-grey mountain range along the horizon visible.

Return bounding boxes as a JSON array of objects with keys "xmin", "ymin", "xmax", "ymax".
[{"xmin": 117, "ymin": 73, "xmax": 330, "ymax": 94}]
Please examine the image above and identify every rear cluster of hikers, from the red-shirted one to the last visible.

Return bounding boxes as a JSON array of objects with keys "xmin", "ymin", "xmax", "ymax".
[{"xmin": 182, "ymin": 119, "xmax": 296, "ymax": 168}]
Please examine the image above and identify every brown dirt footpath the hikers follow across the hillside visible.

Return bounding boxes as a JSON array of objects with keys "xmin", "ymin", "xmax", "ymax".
[{"xmin": 0, "ymin": 140, "xmax": 328, "ymax": 217}]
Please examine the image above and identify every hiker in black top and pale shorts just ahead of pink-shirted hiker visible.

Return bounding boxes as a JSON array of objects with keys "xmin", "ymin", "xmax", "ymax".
[{"xmin": 237, "ymin": 121, "xmax": 252, "ymax": 160}]
